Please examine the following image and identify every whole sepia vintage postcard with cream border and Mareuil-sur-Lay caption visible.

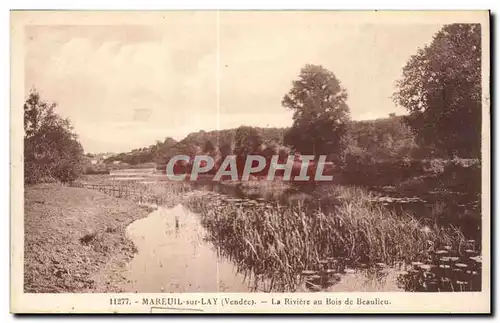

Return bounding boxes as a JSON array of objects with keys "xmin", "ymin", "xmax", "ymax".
[{"xmin": 10, "ymin": 10, "xmax": 491, "ymax": 313}]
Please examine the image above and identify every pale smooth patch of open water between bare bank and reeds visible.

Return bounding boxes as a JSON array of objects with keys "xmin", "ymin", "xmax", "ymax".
[{"xmin": 120, "ymin": 205, "xmax": 249, "ymax": 293}]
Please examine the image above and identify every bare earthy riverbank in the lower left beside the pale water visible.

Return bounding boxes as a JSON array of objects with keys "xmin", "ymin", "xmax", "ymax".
[{"xmin": 24, "ymin": 184, "xmax": 148, "ymax": 293}]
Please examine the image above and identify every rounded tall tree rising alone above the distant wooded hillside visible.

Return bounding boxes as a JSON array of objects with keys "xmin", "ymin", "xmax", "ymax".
[{"xmin": 282, "ymin": 65, "xmax": 349, "ymax": 160}]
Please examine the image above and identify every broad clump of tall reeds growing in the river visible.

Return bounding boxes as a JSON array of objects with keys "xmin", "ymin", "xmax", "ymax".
[{"xmin": 188, "ymin": 187, "xmax": 463, "ymax": 291}]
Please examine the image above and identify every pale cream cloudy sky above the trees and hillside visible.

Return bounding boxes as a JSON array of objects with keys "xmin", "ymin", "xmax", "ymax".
[{"xmin": 25, "ymin": 12, "xmax": 442, "ymax": 153}]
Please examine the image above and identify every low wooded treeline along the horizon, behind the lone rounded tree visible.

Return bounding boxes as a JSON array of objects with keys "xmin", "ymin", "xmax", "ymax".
[{"xmin": 106, "ymin": 116, "xmax": 423, "ymax": 168}]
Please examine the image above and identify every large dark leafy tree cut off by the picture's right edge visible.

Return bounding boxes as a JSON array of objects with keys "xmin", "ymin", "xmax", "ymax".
[{"xmin": 394, "ymin": 24, "xmax": 482, "ymax": 157}]
